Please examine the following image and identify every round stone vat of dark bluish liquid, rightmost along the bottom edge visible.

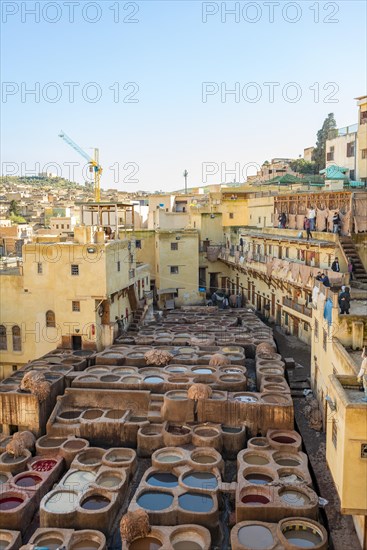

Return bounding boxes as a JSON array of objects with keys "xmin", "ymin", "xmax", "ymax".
[{"xmin": 278, "ymin": 518, "xmax": 327, "ymax": 548}]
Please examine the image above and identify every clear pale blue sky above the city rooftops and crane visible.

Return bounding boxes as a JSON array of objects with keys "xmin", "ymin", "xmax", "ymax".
[{"xmin": 1, "ymin": 0, "xmax": 366, "ymax": 191}]
